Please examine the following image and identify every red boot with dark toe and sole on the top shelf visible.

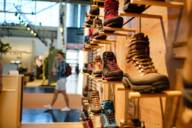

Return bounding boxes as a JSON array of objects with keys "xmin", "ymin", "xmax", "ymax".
[{"xmin": 104, "ymin": 0, "xmax": 123, "ymax": 28}]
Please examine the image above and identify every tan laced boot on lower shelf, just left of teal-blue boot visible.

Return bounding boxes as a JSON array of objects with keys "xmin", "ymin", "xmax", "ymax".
[{"xmin": 90, "ymin": 90, "xmax": 101, "ymax": 113}]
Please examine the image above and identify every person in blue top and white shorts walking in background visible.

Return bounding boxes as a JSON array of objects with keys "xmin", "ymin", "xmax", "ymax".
[{"xmin": 45, "ymin": 51, "xmax": 70, "ymax": 111}]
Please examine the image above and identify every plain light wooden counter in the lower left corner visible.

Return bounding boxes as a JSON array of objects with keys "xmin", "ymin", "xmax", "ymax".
[{"xmin": 0, "ymin": 75, "xmax": 22, "ymax": 128}]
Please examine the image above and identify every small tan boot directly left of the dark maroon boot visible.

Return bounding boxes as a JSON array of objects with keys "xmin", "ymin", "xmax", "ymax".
[{"xmin": 93, "ymin": 56, "xmax": 103, "ymax": 77}]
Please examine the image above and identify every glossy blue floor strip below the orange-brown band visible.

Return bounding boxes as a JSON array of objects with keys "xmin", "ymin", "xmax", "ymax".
[{"xmin": 22, "ymin": 109, "xmax": 80, "ymax": 123}]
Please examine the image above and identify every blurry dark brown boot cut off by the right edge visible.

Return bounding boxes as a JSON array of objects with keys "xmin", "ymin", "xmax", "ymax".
[{"xmin": 183, "ymin": 80, "xmax": 192, "ymax": 109}]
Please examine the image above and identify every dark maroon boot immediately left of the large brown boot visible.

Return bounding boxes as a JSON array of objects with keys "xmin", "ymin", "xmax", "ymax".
[{"xmin": 103, "ymin": 51, "xmax": 123, "ymax": 81}]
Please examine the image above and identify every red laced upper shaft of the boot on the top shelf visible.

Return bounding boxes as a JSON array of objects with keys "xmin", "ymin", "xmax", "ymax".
[{"xmin": 104, "ymin": 0, "xmax": 119, "ymax": 16}]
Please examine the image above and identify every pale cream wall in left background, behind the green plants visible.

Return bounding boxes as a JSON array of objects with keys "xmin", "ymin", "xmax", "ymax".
[{"xmin": 1, "ymin": 37, "xmax": 50, "ymax": 71}]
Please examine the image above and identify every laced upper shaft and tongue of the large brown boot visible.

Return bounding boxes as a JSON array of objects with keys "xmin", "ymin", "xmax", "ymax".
[{"xmin": 127, "ymin": 33, "xmax": 157, "ymax": 75}]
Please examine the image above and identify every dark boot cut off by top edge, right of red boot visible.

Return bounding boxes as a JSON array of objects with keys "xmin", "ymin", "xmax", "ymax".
[{"xmin": 123, "ymin": 0, "xmax": 147, "ymax": 13}]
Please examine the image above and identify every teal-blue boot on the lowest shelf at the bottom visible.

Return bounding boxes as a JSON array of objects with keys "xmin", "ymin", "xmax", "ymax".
[{"xmin": 101, "ymin": 100, "xmax": 118, "ymax": 128}]
